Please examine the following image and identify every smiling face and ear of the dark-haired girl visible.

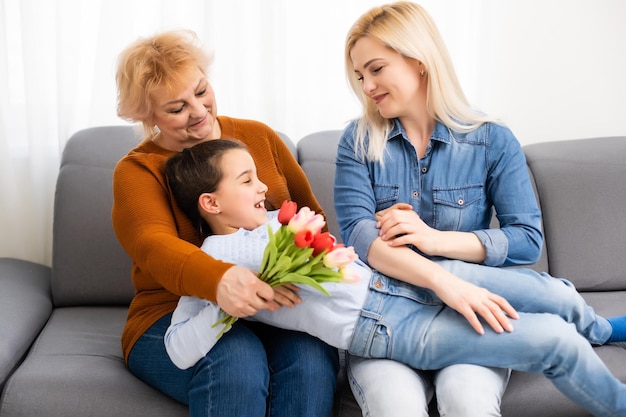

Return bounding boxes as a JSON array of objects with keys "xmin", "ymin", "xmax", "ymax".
[{"xmin": 200, "ymin": 149, "xmax": 267, "ymax": 234}]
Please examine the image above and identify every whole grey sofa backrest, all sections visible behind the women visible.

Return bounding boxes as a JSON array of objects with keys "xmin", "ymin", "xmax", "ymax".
[{"xmin": 52, "ymin": 126, "xmax": 626, "ymax": 307}]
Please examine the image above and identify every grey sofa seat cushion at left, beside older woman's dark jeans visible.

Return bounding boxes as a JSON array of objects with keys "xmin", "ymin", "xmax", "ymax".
[{"xmin": 0, "ymin": 306, "xmax": 189, "ymax": 417}]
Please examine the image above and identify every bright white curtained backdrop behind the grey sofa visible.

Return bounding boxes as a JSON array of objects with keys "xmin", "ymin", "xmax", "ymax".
[{"xmin": 0, "ymin": 0, "xmax": 626, "ymax": 264}]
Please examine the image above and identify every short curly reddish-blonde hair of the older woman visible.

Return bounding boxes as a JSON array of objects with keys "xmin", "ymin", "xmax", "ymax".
[{"xmin": 115, "ymin": 30, "xmax": 211, "ymax": 136}]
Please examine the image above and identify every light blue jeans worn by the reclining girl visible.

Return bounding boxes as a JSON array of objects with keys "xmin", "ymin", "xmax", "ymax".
[{"xmin": 349, "ymin": 261, "xmax": 626, "ymax": 416}]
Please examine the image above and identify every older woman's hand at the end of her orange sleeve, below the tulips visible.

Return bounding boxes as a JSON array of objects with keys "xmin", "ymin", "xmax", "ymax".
[{"xmin": 216, "ymin": 265, "xmax": 278, "ymax": 317}]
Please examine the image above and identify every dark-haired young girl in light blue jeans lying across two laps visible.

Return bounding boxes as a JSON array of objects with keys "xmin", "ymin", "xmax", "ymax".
[{"xmin": 165, "ymin": 140, "xmax": 626, "ymax": 416}]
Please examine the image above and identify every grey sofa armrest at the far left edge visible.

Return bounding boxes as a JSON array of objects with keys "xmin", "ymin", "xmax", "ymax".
[{"xmin": 0, "ymin": 258, "xmax": 52, "ymax": 390}]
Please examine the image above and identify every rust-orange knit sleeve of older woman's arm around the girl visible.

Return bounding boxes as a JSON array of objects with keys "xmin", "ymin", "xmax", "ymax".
[{"xmin": 112, "ymin": 152, "xmax": 225, "ymax": 300}]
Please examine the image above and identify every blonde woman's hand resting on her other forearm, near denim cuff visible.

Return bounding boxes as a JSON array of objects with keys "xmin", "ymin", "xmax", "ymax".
[{"xmin": 376, "ymin": 203, "xmax": 441, "ymax": 255}]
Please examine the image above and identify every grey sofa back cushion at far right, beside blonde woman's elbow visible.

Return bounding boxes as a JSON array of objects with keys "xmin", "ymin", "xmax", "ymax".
[{"xmin": 524, "ymin": 137, "xmax": 626, "ymax": 291}]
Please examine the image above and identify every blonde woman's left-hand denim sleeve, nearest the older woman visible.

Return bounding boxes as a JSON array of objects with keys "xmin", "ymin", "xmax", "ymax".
[{"xmin": 334, "ymin": 124, "xmax": 378, "ymax": 262}]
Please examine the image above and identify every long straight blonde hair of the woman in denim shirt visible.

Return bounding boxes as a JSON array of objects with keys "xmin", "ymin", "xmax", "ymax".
[{"xmin": 345, "ymin": 1, "xmax": 495, "ymax": 161}]
